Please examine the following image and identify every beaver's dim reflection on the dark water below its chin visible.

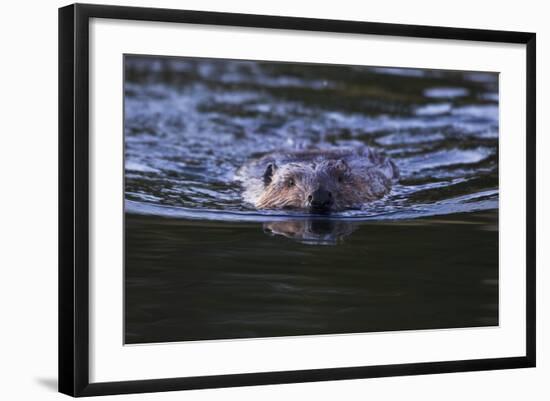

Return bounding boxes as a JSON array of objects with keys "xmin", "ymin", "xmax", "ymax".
[{"xmin": 263, "ymin": 219, "xmax": 357, "ymax": 245}]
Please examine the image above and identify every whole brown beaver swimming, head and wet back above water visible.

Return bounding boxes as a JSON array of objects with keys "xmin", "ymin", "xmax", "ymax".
[{"xmin": 237, "ymin": 146, "xmax": 399, "ymax": 213}]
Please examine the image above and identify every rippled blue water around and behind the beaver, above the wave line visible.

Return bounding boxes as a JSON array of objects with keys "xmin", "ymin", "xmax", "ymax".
[{"xmin": 124, "ymin": 57, "xmax": 499, "ymax": 221}]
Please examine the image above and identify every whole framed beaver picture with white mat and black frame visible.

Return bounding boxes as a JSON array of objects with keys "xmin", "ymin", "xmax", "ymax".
[{"xmin": 59, "ymin": 4, "xmax": 535, "ymax": 396}]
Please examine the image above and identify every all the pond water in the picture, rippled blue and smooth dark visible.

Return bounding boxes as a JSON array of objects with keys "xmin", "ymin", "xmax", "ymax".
[{"xmin": 124, "ymin": 56, "xmax": 499, "ymax": 343}]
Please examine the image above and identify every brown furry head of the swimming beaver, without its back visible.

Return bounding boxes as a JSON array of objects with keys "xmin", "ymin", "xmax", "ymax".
[{"xmin": 256, "ymin": 160, "xmax": 360, "ymax": 213}]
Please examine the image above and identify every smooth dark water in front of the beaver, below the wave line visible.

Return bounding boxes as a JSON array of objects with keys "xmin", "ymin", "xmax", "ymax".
[{"xmin": 126, "ymin": 212, "xmax": 498, "ymax": 343}]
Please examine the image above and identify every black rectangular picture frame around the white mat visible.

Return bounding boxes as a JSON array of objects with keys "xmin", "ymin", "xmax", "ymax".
[{"xmin": 59, "ymin": 4, "xmax": 536, "ymax": 396}]
